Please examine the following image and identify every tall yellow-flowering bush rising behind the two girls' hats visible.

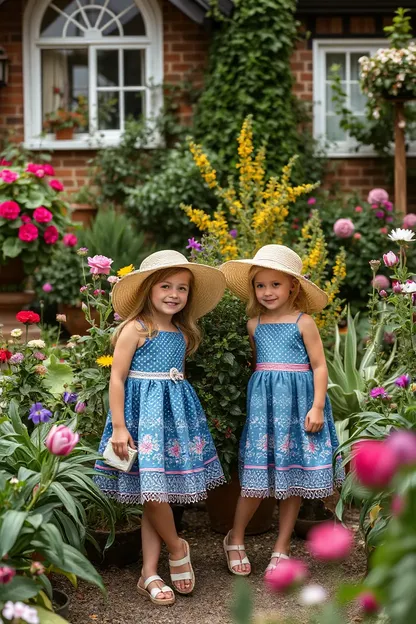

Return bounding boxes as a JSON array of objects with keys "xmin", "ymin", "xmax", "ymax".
[{"xmin": 182, "ymin": 116, "xmax": 346, "ymax": 340}]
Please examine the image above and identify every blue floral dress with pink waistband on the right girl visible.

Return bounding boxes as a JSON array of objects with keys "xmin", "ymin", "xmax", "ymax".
[{"xmin": 240, "ymin": 314, "xmax": 343, "ymax": 499}]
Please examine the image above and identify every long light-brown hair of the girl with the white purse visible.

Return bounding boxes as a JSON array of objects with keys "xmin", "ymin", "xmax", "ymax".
[{"xmin": 111, "ymin": 267, "xmax": 201, "ymax": 355}]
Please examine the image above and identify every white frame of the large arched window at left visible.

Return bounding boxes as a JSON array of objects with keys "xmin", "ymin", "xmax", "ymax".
[{"xmin": 23, "ymin": 0, "xmax": 163, "ymax": 150}]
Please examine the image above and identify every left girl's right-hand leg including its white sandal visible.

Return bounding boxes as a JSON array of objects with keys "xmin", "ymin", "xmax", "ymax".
[{"xmin": 146, "ymin": 501, "xmax": 191, "ymax": 591}]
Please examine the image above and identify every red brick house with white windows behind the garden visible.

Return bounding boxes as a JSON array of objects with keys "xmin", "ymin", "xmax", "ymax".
[{"xmin": 0, "ymin": 0, "xmax": 416, "ymax": 204}]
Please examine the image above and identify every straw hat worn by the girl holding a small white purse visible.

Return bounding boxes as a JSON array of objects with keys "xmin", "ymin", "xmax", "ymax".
[{"xmin": 112, "ymin": 249, "xmax": 226, "ymax": 319}]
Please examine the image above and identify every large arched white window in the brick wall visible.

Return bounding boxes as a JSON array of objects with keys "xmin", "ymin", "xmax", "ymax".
[{"xmin": 24, "ymin": 0, "xmax": 163, "ymax": 149}]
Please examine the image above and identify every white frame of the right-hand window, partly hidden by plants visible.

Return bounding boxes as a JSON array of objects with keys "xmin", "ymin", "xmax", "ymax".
[{"xmin": 313, "ymin": 39, "xmax": 410, "ymax": 158}]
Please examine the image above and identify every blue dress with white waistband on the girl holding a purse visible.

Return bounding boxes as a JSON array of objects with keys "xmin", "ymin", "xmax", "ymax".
[{"xmin": 94, "ymin": 331, "xmax": 225, "ymax": 503}]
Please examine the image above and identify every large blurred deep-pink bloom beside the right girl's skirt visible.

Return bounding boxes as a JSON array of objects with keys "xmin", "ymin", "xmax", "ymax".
[{"xmin": 352, "ymin": 440, "xmax": 398, "ymax": 489}]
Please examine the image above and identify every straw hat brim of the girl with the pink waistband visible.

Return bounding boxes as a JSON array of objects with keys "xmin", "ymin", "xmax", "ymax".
[{"xmin": 220, "ymin": 260, "xmax": 328, "ymax": 314}]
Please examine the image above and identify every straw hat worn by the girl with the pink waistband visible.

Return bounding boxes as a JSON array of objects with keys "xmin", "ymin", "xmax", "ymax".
[{"xmin": 220, "ymin": 245, "xmax": 328, "ymax": 314}]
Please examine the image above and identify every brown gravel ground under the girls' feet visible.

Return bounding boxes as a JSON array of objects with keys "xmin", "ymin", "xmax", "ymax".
[{"xmin": 59, "ymin": 508, "xmax": 365, "ymax": 624}]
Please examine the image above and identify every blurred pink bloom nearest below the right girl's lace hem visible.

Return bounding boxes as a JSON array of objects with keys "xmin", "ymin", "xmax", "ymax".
[{"xmin": 308, "ymin": 521, "xmax": 354, "ymax": 561}]
